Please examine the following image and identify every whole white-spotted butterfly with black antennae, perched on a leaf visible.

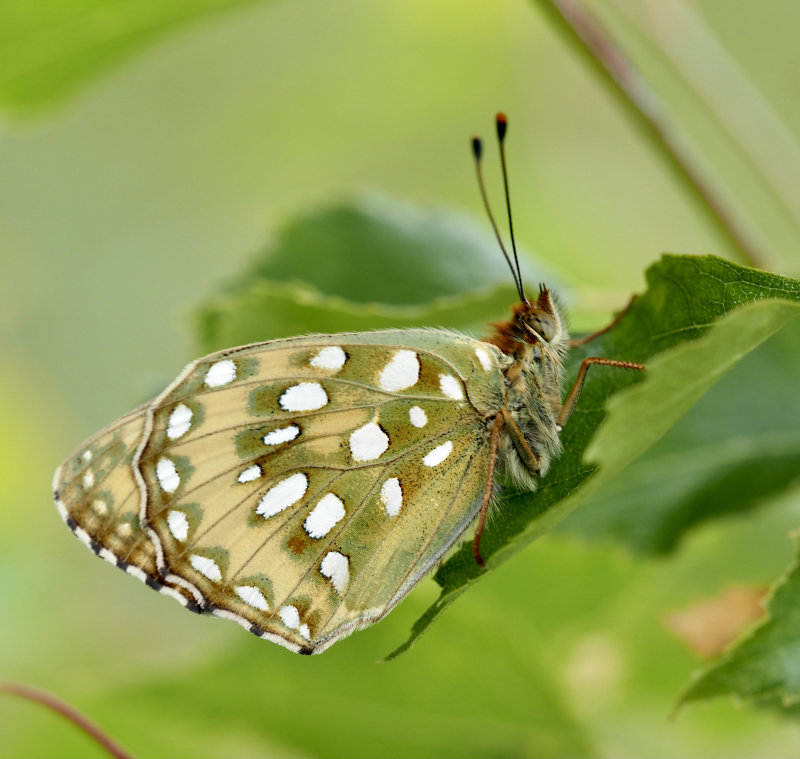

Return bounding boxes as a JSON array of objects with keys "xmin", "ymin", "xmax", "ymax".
[{"xmin": 53, "ymin": 114, "xmax": 643, "ymax": 654}]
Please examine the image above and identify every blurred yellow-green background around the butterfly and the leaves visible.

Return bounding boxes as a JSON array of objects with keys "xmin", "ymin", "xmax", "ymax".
[{"xmin": 0, "ymin": 0, "xmax": 800, "ymax": 757}]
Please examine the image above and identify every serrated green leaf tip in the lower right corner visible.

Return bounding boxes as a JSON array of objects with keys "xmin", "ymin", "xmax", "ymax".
[{"xmin": 678, "ymin": 534, "xmax": 800, "ymax": 716}]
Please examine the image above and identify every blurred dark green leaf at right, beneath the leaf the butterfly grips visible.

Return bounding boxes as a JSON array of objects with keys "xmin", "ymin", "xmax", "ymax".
[{"xmin": 558, "ymin": 320, "xmax": 800, "ymax": 554}]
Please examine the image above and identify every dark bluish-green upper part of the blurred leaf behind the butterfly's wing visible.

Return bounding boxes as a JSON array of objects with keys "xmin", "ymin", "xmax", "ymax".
[{"xmin": 203, "ymin": 194, "xmax": 543, "ymax": 306}]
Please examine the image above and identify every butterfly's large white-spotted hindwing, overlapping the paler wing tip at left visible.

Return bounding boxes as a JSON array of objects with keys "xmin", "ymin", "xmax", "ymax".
[{"xmin": 133, "ymin": 330, "xmax": 503, "ymax": 653}]
